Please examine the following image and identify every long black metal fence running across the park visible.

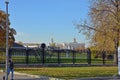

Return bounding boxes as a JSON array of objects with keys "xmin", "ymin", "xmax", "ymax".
[{"xmin": 0, "ymin": 48, "xmax": 115, "ymax": 64}]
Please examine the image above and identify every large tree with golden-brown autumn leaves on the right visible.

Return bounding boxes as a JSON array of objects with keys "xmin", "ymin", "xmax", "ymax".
[{"xmin": 76, "ymin": 0, "xmax": 120, "ymax": 63}]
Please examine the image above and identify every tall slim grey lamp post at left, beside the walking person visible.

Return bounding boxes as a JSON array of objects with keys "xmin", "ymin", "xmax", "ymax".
[{"xmin": 5, "ymin": 0, "xmax": 9, "ymax": 80}]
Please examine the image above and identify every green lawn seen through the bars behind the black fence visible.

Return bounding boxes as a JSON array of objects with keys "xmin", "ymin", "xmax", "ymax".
[{"xmin": 0, "ymin": 56, "xmax": 114, "ymax": 64}]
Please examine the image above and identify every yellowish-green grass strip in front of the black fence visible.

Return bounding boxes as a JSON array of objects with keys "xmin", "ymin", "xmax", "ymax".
[{"xmin": 15, "ymin": 66, "xmax": 117, "ymax": 79}]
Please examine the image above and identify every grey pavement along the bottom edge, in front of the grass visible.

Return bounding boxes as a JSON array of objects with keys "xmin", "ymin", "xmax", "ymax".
[{"xmin": 0, "ymin": 72, "xmax": 120, "ymax": 80}]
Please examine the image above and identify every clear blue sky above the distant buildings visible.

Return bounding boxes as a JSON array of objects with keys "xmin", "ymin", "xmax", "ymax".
[{"xmin": 0, "ymin": 0, "xmax": 89, "ymax": 43}]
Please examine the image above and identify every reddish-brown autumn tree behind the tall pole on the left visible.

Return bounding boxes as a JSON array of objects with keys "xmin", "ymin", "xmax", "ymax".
[{"xmin": 0, "ymin": 10, "xmax": 16, "ymax": 47}]
